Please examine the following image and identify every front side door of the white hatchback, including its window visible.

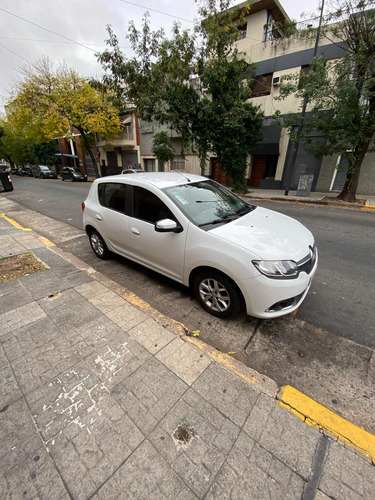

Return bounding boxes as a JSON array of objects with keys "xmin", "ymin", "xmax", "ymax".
[{"xmin": 129, "ymin": 186, "xmax": 187, "ymax": 281}]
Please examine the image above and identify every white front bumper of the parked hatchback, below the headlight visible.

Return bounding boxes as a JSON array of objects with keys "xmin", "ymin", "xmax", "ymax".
[{"xmin": 238, "ymin": 251, "xmax": 318, "ymax": 319}]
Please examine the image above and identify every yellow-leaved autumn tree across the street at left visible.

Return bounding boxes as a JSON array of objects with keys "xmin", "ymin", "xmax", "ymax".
[{"xmin": 9, "ymin": 59, "xmax": 121, "ymax": 176}]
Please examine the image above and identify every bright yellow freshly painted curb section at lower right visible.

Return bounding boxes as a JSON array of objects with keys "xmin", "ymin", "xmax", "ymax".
[{"xmin": 278, "ymin": 385, "xmax": 375, "ymax": 464}]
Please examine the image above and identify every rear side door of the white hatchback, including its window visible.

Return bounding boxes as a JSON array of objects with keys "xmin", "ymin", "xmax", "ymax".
[{"xmin": 94, "ymin": 182, "xmax": 132, "ymax": 257}]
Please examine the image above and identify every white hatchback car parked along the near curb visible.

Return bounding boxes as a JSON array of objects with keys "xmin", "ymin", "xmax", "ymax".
[{"xmin": 82, "ymin": 172, "xmax": 318, "ymax": 318}]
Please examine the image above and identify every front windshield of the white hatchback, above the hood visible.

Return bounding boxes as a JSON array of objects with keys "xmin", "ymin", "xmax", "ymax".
[{"xmin": 164, "ymin": 180, "xmax": 255, "ymax": 227}]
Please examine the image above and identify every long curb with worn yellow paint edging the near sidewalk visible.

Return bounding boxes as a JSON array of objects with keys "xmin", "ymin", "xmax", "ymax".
[{"xmin": 0, "ymin": 213, "xmax": 375, "ymax": 465}]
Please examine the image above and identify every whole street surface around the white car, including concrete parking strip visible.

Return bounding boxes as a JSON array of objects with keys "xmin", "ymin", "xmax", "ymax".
[{"xmin": 0, "ymin": 176, "xmax": 375, "ymax": 433}]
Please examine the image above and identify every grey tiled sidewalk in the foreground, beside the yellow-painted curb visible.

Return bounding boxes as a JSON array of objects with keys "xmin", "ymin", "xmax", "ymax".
[{"xmin": 0, "ymin": 213, "xmax": 375, "ymax": 500}]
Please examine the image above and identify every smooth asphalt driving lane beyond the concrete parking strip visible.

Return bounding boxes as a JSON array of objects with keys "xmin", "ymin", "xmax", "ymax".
[{"xmin": 7, "ymin": 176, "xmax": 375, "ymax": 347}]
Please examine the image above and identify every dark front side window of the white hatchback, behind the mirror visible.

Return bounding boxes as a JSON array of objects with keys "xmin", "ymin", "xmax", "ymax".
[{"xmin": 133, "ymin": 186, "xmax": 175, "ymax": 224}]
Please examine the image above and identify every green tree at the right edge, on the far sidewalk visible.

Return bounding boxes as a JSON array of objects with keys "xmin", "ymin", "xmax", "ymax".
[{"xmin": 280, "ymin": 0, "xmax": 375, "ymax": 201}]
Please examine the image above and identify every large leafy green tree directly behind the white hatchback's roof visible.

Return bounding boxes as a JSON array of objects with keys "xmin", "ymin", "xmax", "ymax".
[{"xmin": 99, "ymin": 0, "xmax": 263, "ymax": 191}]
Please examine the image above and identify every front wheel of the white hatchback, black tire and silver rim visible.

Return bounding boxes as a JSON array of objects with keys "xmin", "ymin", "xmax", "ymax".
[{"xmin": 194, "ymin": 270, "xmax": 241, "ymax": 318}]
